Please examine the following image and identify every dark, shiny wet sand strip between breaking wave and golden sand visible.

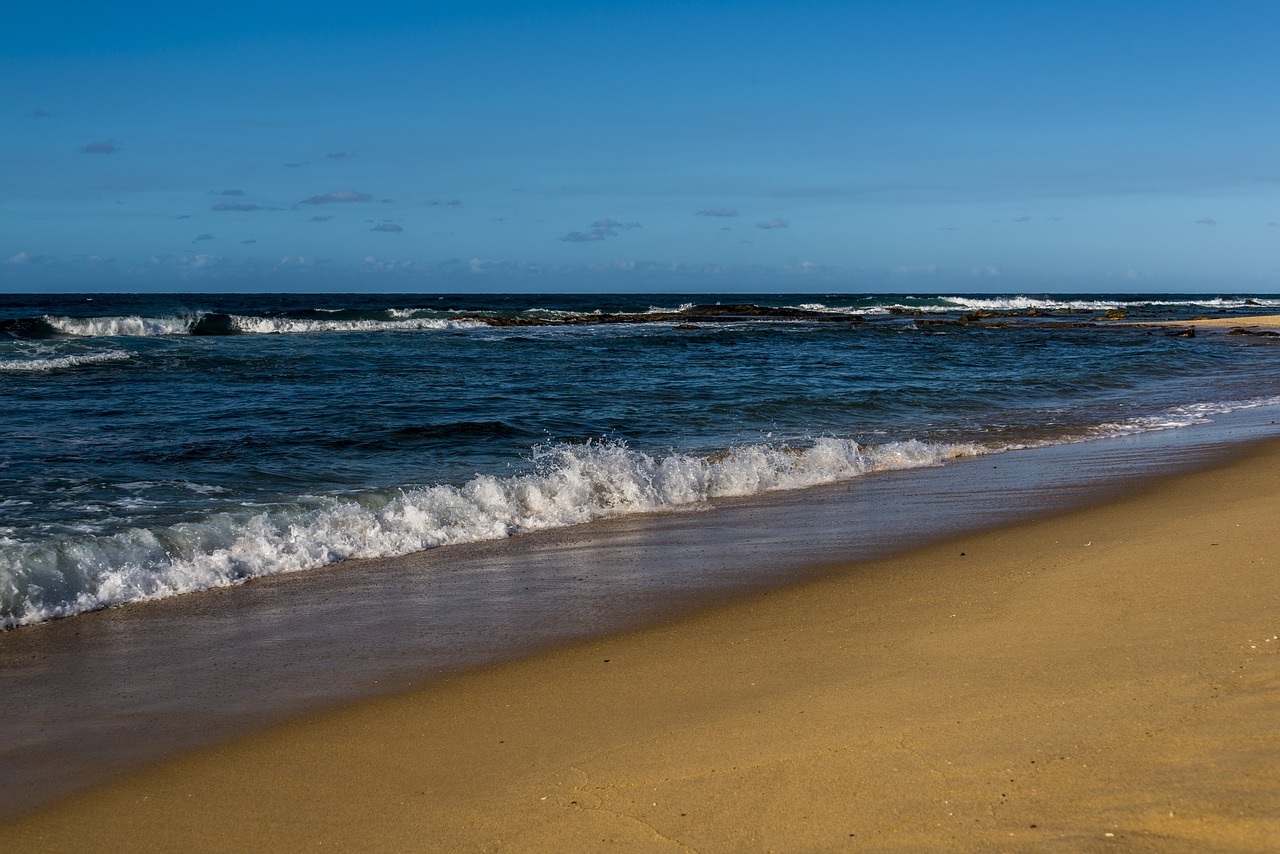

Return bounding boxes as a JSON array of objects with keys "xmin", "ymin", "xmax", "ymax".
[{"xmin": 0, "ymin": 407, "xmax": 1277, "ymax": 821}]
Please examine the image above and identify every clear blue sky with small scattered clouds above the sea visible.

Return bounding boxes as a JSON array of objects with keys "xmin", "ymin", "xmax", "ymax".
[{"xmin": 0, "ymin": 0, "xmax": 1280, "ymax": 292}]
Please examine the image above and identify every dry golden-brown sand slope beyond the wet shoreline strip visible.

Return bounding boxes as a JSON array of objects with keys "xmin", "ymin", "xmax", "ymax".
[{"xmin": 10, "ymin": 442, "xmax": 1280, "ymax": 851}]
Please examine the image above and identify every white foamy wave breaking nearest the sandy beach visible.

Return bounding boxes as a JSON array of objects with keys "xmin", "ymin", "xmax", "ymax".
[{"xmin": 0, "ymin": 438, "xmax": 984, "ymax": 627}]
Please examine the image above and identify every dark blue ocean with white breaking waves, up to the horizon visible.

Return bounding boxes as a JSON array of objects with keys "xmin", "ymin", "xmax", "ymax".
[{"xmin": 0, "ymin": 293, "xmax": 1280, "ymax": 630}]
